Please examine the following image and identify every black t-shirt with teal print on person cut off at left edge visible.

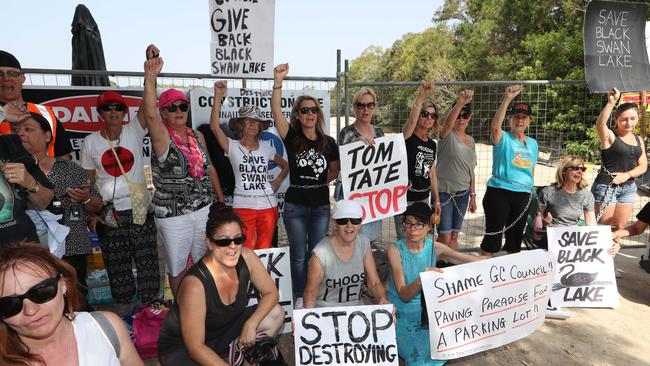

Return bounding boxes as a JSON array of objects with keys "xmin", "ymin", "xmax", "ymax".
[{"xmin": 0, "ymin": 134, "xmax": 53, "ymax": 244}]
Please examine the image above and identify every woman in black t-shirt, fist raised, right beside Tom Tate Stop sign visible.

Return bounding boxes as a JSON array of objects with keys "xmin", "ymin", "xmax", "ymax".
[{"xmin": 394, "ymin": 81, "xmax": 440, "ymax": 239}]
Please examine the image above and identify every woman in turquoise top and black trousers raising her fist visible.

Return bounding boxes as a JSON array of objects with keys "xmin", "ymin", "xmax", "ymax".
[{"xmin": 481, "ymin": 85, "xmax": 538, "ymax": 256}]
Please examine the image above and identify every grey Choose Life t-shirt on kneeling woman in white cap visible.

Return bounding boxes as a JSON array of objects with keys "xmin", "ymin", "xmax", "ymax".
[{"xmin": 312, "ymin": 234, "xmax": 370, "ymax": 307}]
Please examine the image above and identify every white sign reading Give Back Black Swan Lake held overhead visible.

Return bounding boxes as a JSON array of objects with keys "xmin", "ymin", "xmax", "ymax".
[{"xmin": 208, "ymin": 0, "xmax": 275, "ymax": 78}]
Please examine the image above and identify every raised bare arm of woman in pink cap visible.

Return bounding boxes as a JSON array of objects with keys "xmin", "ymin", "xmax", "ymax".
[{"xmin": 140, "ymin": 58, "xmax": 169, "ymax": 156}]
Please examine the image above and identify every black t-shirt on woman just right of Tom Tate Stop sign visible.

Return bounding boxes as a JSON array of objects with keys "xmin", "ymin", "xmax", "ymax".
[{"xmin": 405, "ymin": 134, "xmax": 436, "ymax": 201}]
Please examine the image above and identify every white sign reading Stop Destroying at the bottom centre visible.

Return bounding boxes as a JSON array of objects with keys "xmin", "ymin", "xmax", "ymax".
[{"xmin": 293, "ymin": 304, "xmax": 399, "ymax": 365}]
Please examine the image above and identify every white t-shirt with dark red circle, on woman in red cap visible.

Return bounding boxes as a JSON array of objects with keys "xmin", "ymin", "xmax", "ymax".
[{"xmin": 81, "ymin": 118, "xmax": 147, "ymax": 211}]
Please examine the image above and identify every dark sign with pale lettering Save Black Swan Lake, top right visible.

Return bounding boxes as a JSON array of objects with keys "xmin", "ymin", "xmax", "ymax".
[{"xmin": 583, "ymin": 0, "xmax": 650, "ymax": 93}]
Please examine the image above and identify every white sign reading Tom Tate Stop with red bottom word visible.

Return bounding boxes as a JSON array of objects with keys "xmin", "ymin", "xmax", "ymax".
[{"xmin": 339, "ymin": 134, "xmax": 408, "ymax": 223}]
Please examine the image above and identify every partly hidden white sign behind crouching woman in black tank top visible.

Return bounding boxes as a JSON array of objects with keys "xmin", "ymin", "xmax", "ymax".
[{"xmin": 248, "ymin": 247, "xmax": 293, "ymax": 333}]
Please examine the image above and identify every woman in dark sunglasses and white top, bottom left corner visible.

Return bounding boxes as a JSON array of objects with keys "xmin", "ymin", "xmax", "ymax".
[{"xmin": 0, "ymin": 243, "xmax": 144, "ymax": 366}]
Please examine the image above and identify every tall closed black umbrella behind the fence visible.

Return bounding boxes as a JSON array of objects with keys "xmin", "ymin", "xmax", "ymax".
[{"xmin": 72, "ymin": 4, "xmax": 110, "ymax": 86}]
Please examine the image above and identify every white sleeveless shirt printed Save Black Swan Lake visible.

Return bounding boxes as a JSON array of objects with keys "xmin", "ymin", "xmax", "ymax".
[{"xmin": 226, "ymin": 138, "xmax": 278, "ymax": 210}]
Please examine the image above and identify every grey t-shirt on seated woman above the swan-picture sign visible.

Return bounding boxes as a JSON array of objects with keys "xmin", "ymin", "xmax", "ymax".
[{"xmin": 538, "ymin": 185, "xmax": 594, "ymax": 226}]
